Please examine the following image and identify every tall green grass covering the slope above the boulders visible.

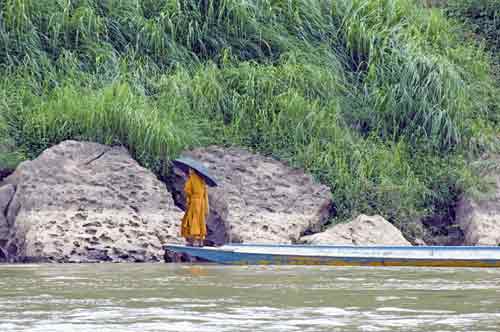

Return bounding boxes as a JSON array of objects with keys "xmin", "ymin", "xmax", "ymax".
[{"xmin": 0, "ymin": 0, "xmax": 500, "ymax": 239}]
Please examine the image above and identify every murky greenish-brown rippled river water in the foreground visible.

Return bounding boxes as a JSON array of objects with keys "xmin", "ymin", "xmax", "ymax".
[{"xmin": 0, "ymin": 264, "xmax": 500, "ymax": 332}]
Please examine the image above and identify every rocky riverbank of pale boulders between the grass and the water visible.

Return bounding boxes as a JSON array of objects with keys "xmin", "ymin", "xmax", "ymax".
[{"xmin": 0, "ymin": 140, "xmax": 500, "ymax": 263}]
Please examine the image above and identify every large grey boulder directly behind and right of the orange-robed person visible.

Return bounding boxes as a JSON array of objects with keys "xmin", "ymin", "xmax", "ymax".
[{"xmin": 169, "ymin": 147, "xmax": 332, "ymax": 243}]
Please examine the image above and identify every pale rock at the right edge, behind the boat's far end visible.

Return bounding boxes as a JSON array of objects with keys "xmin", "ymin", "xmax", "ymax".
[{"xmin": 456, "ymin": 165, "xmax": 500, "ymax": 246}]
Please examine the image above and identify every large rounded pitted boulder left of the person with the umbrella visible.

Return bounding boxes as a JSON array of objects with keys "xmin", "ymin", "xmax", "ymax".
[{"xmin": 0, "ymin": 141, "xmax": 182, "ymax": 262}]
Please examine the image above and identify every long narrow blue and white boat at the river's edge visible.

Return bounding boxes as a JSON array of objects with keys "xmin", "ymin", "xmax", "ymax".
[{"xmin": 164, "ymin": 244, "xmax": 500, "ymax": 267}]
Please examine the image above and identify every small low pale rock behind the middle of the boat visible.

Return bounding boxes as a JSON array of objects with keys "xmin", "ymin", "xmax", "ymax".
[{"xmin": 300, "ymin": 214, "xmax": 411, "ymax": 246}]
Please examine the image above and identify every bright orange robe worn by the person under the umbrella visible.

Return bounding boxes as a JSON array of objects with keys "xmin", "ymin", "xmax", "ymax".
[{"xmin": 181, "ymin": 172, "xmax": 208, "ymax": 240}]
